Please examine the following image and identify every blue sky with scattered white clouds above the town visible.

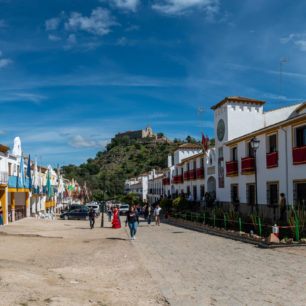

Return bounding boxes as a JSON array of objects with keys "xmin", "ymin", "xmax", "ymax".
[{"xmin": 0, "ymin": 0, "xmax": 306, "ymax": 165}]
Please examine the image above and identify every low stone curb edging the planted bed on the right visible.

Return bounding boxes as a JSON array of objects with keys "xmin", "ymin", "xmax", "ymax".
[{"xmin": 164, "ymin": 220, "xmax": 306, "ymax": 249}]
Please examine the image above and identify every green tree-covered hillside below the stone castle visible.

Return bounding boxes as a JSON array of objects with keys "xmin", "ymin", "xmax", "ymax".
[{"xmin": 62, "ymin": 136, "xmax": 181, "ymax": 200}]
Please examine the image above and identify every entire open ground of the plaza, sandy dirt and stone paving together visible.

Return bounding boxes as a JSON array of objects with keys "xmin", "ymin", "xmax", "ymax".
[{"xmin": 0, "ymin": 219, "xmax": 306, "ymax": 306}]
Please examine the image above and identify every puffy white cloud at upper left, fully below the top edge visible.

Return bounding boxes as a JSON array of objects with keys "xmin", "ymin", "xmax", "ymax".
[{"xmin": 65, "ymin": 7, "xmax": 118, "ymax": 36}]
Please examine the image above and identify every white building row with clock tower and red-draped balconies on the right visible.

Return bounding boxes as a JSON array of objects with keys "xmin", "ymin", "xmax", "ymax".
[{"xmin": 126, "ymin": 97, "xmax": 306, "ymax": 213}]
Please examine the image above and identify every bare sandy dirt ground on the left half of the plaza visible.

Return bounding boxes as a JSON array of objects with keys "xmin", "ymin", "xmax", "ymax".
[{"xmin": 0, "ymin": 219, "xmax": 167, "ymax": 306}]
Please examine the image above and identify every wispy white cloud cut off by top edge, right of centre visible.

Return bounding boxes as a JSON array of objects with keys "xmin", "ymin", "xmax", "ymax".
[{"xmin": 152, "ymin": 0, "xmax": 219, "ymax": 18}]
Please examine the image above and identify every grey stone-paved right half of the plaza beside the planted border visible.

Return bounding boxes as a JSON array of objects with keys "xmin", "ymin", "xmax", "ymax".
[{"xmin": 133, "ymin": 222, "xmax": 306, "ymax": 305}]
